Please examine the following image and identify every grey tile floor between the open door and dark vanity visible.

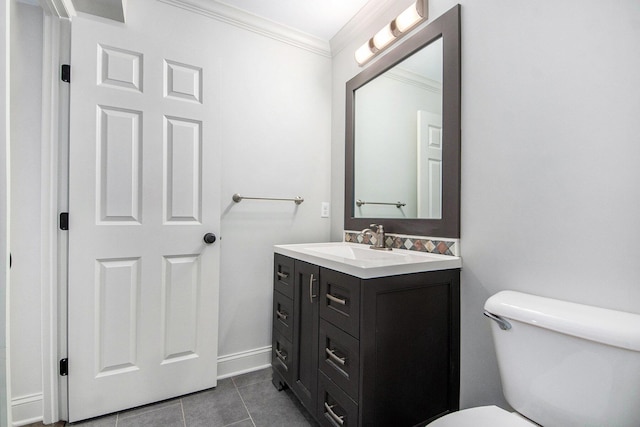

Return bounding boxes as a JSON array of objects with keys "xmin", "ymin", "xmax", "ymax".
[{"xmin": 58, "ymin": 368, "xmax": 318, "ymax": 427}]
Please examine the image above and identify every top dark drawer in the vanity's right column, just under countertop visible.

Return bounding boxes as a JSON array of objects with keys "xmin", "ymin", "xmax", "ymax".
[{"xmin": 319, "ymin": 269, "xmax": 360, "ymax": 338}]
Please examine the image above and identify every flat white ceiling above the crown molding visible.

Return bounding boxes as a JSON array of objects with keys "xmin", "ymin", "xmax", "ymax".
[{"xmin": 215, "ymin": 0, "xmax": 368, "ymax": 41}]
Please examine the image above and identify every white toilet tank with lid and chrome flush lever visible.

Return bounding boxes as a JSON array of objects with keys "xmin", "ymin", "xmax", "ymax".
[{"xmin": 484, "ymin": 291, "xmax": 640, "ymax": 427}]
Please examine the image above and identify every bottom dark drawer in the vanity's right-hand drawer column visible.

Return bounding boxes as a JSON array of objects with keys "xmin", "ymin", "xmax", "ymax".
[{"xmin": 317, "ymin": 372, "xmax": 358, "ymax": 427}]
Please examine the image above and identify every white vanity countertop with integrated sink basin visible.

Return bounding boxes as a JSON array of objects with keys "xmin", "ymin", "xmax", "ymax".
[{"xmin": 274, "ymin": 242, "xmax": 462, "ymax": 279}]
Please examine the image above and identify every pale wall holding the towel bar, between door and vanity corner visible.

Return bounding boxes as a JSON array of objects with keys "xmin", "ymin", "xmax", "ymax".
[{"xmin": 214, "ymin": 13, "xmax": 331, "ymax": 356}]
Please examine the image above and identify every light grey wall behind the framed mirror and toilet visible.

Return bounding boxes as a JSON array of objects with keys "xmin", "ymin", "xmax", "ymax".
[{"xmin": 331, "ymin": 0, "xmax": 640, "ymax": 407}]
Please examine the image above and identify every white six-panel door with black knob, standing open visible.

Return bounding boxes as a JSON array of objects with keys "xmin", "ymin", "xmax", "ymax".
[{"xmin": 68, "ymin": 12, "xmax": 220, "ymax": 421}]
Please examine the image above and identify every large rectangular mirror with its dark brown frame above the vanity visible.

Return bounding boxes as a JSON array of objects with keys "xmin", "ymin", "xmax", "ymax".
[{"xmin": 345, "ymin": 5, "xmax": 460, "ymax": 238}]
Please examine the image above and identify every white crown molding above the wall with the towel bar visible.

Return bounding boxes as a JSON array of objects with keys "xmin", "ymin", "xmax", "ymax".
[{"xmin": 158, "ymin": 0, "xmax": 331, "ymax": 58}]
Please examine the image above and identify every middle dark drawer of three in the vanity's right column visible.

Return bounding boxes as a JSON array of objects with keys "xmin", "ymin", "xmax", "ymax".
[{"xmin": 318, "ymin": 320, "xmax": 360, "ymax": 401}]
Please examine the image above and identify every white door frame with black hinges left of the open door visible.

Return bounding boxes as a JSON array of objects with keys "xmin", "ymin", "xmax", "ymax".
[{"xmin": 40, "ymin": 0, "xmax": 75, "ymax": 424}]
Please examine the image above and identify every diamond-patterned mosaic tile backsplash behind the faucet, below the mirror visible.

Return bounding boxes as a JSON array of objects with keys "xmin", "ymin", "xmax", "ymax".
[{"xmin": 344, "ymin": 230, "xmax": 460, "ymax": 256}]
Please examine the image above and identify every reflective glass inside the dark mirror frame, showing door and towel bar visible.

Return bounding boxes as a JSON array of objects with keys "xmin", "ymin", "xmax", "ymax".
[{"xmin": 354, "ymin": 38, "xmax": 442, "ymax": 219}]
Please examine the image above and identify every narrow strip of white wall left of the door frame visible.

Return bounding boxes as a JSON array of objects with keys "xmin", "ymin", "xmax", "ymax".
[{"xmin": 10, "ymin": 1, "xmax": 42, "ymax": 421}]
